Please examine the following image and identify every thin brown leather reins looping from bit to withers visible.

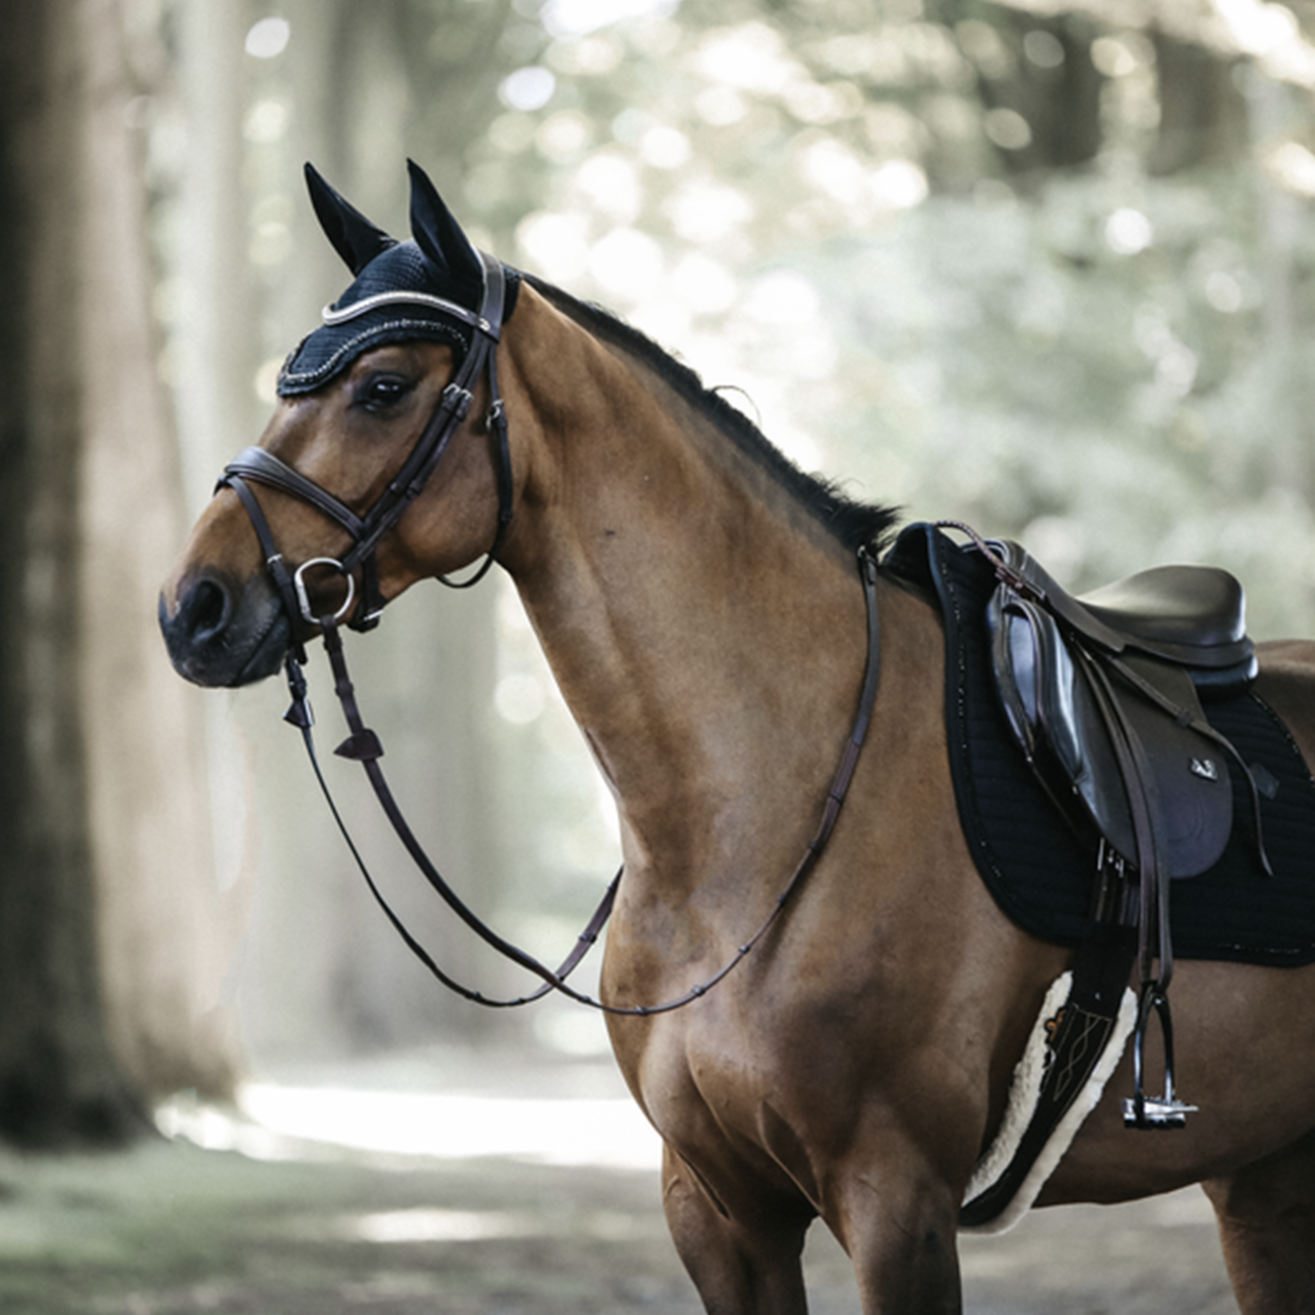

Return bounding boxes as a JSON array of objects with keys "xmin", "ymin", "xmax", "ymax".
[{"xmin": 285, "ymin": 550, "xmax": 881, "ymax": 1016}]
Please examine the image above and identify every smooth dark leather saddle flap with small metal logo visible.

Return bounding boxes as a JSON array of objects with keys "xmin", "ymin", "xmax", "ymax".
[{"xmin": 988, "ymin": 585, "xmax": 1232, "ymax": 877}]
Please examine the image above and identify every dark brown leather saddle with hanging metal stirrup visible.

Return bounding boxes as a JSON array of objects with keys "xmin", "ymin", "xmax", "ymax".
[{"xmin": 956, "ymin": 525, "xmax": 1268, "ymax": 1128}]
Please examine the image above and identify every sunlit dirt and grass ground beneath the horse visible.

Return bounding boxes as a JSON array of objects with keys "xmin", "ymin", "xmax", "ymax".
[{"xmin": 0, "ymin": 1052, "xmax": 1236, "ymax": 1315}]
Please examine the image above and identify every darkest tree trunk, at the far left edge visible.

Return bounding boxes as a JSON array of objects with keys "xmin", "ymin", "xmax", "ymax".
[{"xmin": 0, "ymin": 0, "xmax": 138, "ymax": 1144}]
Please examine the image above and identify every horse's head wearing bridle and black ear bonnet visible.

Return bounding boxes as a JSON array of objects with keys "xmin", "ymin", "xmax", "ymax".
[{"xmin": 160, "ymin": 164, "xmax": 517, "ymax": 685}]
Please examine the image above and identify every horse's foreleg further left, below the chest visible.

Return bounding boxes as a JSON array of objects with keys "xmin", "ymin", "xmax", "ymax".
[{"xmin": 663, "ymin": 1148, "xmax": 807, "ymax": 1315}]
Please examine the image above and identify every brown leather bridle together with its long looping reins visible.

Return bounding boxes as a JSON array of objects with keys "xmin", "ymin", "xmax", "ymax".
[{"xmin": 220, "ymin": 256, "xmax": 881, "ymax": 1016}]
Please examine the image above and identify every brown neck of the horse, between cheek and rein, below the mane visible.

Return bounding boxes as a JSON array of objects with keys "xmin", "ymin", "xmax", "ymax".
[{"xmin": 512, "ymin": 297, "xmax": 865, "ymax": 899}]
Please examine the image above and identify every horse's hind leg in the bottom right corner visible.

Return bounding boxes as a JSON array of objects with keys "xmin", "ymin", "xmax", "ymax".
[{"xmin": 1203, "ymin": 1132, "xmax": 1315, "ymax": 1315}]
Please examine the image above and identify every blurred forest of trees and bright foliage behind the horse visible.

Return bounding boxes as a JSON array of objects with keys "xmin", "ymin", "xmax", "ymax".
[{"xmin": 0, "ymin": 0, "xmax": 1315, "ymax": 1144}]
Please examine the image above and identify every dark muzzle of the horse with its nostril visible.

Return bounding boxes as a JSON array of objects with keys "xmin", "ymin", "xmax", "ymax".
[{"xmin": 159, "ymin": 575, "xmax": 292, "ymax": 686}]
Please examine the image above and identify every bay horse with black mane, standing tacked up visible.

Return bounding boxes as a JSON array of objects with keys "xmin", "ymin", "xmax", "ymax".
[{"xmin": 160, "ymin": 166, "xmax": 1315, "ymax": 1315}]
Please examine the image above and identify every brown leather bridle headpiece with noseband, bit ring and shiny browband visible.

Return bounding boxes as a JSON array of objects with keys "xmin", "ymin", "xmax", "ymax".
[{"xmin": 217, "ymin": 252, "xmax": 513, "ymax": 646}]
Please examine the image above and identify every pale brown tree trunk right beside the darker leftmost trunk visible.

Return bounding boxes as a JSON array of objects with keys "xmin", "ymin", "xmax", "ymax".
[{"xmin": 78, "ymin": 0, "xmax": 250, "ymax": 1095}]
